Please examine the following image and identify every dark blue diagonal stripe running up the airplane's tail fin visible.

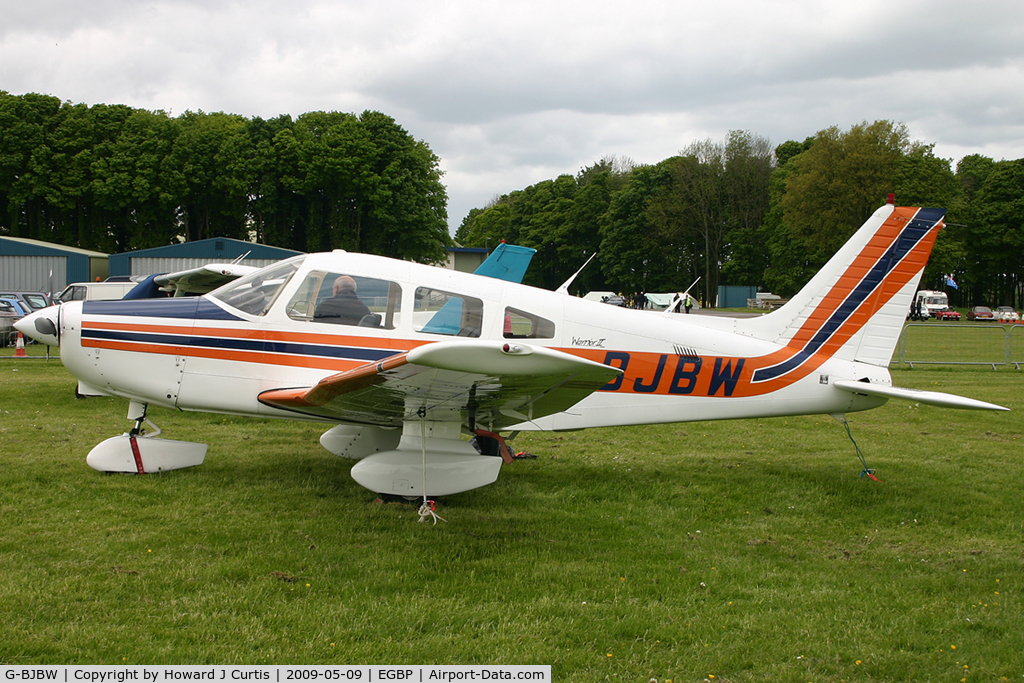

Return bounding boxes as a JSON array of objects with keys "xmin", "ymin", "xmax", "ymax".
[{"xmin": 751, "ymin": 209, "xmax": 945, "ymax": 382}]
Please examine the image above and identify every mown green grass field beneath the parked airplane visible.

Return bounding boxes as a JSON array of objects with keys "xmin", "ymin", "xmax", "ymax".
[{"xmin": 0, "ymin": 358, "xmax": 1024, "ymax": 683}]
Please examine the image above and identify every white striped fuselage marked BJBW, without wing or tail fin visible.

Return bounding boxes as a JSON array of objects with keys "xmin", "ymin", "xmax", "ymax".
[{"xmin": 59, "ymin": 245, "xmax": 889, "ymax": 429}]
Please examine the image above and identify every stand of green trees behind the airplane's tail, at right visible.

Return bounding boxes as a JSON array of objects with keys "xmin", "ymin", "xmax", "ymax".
[{"xmin": 456, "ymin": 121, "xmax": 1024, "ymax": 306}]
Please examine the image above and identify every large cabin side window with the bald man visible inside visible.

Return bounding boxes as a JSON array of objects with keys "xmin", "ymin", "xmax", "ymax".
[{"xmin": 288, "ymin": 270, "xmax": 401, "ymax": 330}]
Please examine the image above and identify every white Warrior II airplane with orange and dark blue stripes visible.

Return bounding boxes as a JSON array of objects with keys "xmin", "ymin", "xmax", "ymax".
[{"xmin": 17, "ymin": 203, "xmax": 1007, "ymax": 498}]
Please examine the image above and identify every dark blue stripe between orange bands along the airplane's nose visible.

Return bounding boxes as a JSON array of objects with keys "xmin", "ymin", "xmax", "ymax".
[{"xmin": 82, "ymin": 330, "xmax": 395, "ymax": 360}]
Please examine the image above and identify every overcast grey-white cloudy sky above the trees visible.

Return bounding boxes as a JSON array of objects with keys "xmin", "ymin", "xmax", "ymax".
[{"xmin": 0, "ymin": 0, "xmax": 1024, "ymax": 231}]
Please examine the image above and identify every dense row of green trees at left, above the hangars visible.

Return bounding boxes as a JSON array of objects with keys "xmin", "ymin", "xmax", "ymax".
[{"xmin": 0, "ymin": 91, "xmax": 451, "ymax": 262}]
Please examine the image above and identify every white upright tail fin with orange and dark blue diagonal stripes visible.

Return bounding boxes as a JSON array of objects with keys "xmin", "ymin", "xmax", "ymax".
[{"xmin": 742, "ymin": 204, "xmax": 945, "ymax": 370}]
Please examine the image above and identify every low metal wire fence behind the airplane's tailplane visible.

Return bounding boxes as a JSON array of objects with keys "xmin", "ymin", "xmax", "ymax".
[{"xmin": 890, "ymin": 323, "xmax": 1024, "ymax": 370}]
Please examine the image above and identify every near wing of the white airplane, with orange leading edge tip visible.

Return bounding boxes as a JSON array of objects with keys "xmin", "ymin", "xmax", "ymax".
[{"xmin": 259, "ymin": 340, "xmax": 622, "ymax": 431}]
